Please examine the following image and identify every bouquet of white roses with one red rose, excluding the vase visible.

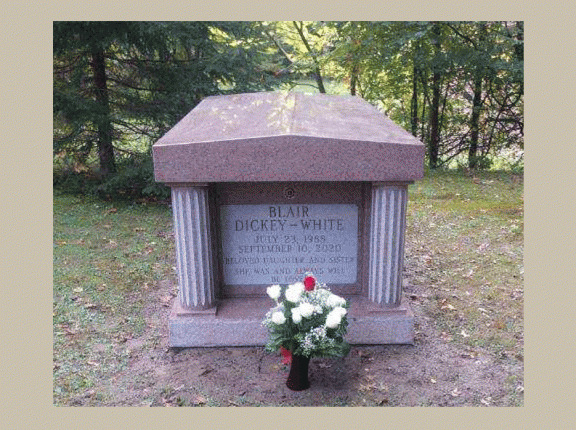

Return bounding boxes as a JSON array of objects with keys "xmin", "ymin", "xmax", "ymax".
[{"xmin": 262, "ymin": 273, "xmax": 350, "ymax": 364}]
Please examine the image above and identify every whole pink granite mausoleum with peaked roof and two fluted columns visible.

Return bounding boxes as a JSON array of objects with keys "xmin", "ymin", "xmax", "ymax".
[{"xmin": 153, "ymin": 92, "xmax": 424, "ymax": 347}]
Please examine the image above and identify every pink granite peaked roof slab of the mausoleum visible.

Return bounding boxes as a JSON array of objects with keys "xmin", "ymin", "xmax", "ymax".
[{"xmin": 153, "ymin": 92, "xmax": 424, "ymax": 183}]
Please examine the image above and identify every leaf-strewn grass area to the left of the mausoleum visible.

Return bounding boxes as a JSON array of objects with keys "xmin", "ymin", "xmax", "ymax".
[{"xmin": 53, "ymin": 194, "xmax": 174, "ymax": 404}]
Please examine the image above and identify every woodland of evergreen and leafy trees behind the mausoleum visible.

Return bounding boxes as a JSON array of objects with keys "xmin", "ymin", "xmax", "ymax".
[{"xmin": 53, "ymin": 21, "xmax": 524, "ymax": 199}]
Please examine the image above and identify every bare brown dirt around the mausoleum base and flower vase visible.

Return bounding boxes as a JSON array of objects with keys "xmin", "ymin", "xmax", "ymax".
[{"xmin": 71, "ymin": 274, "xmax": 524, "ymax": 407}]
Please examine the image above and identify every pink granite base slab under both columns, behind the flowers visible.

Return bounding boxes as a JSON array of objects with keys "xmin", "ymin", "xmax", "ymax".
[{"xmin": 168, "ymin": 296, "xmax": 414, "ymax": 348}]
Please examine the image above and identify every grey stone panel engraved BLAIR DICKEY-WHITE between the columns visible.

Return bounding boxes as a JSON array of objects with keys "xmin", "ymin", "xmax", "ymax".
[{"xmin": 220, "ymin": 204, "xmax": 358, "ymax": 285}]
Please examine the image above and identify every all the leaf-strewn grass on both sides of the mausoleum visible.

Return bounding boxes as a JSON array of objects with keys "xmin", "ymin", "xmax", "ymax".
[{"xmin": 53, "ymin": 171, "xmax": 524, "ymax": 406}]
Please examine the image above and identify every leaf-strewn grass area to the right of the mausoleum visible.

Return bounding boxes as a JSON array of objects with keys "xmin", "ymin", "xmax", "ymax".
[{"xmin": 406, "ymin": 171, "xmax": 524, "ymax": 358}]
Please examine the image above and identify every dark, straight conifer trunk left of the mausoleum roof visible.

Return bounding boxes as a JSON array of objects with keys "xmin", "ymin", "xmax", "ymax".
[{"xmin": 91, "ymin": 50, "xmax": 116, "ymax": 177}]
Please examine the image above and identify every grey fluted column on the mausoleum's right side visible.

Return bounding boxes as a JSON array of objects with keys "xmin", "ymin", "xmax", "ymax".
[{"xmin": 368, "ymin": 184, "xmax": 408, "ymax": 306}]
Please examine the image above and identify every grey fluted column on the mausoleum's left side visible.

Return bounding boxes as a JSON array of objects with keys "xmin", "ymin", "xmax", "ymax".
[{"xmin": 172, "ymin": 186, "xmax": 214, "ymax": 310}]
